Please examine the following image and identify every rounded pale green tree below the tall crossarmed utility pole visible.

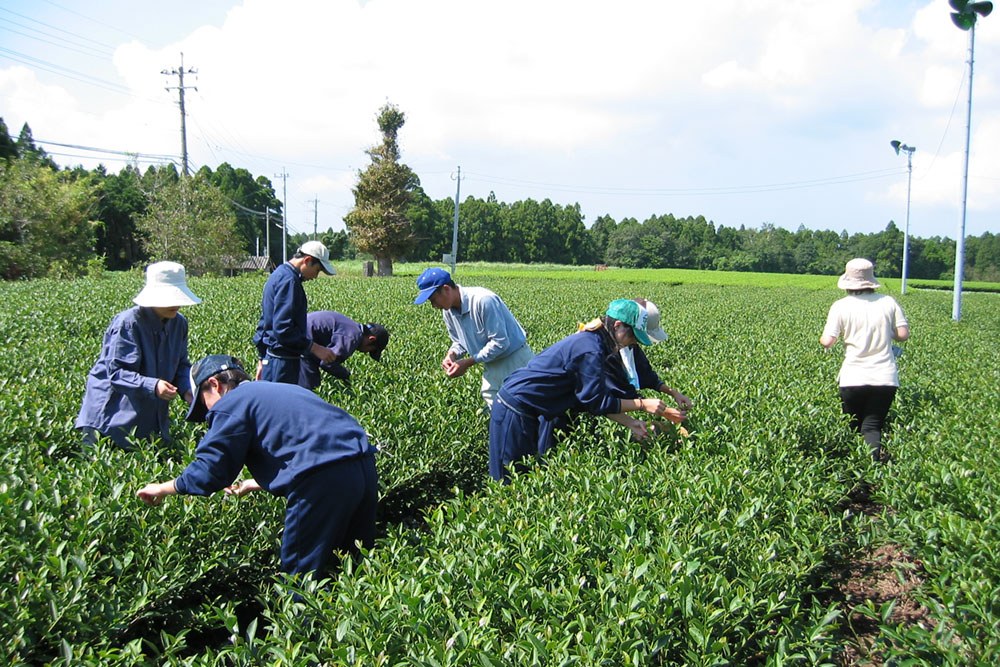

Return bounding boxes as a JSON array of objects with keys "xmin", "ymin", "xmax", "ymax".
[{"xmin": 137, "ymin": 172, "xmax": 244, "ymax": 275}]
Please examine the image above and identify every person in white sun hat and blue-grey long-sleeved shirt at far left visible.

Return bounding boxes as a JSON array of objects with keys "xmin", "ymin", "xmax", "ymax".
[{"xmin": 76, "ymin": 262, "xmax": 201, "ymax": 449}]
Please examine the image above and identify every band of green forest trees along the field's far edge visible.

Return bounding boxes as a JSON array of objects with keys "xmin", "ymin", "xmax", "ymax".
[{"xmin": 0, "ymin": 115, "xmax": 1000, "ymax": 282}]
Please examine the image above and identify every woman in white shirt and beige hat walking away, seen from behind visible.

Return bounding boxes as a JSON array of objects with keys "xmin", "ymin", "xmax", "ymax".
[{"xmin": 819, "ymin": 258, "xmax": 910, "ymax": 461}]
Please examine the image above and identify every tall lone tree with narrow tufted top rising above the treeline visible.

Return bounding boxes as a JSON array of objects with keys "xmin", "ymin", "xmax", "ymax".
[{"xmin": 344, "ymin": 104, "xmax": 420, "ymax": 276}]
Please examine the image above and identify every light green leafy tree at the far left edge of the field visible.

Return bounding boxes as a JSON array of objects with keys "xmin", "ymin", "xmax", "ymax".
[{"xmin": 0, "ymin": 156, "xmax": 94, "ymax": 280}]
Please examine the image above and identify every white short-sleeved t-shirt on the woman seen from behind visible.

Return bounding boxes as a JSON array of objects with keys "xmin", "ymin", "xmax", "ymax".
[{"xmin": 823, "ymin": 293, "xmax": 909, "ymax": 387}]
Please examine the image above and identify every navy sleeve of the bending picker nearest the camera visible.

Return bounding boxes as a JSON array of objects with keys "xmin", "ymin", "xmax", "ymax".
[{"xmin": 174, "ymin": 412, "xmax": 251, "ymax": 496}]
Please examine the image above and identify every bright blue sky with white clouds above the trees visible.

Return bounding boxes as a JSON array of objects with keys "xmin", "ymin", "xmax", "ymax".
[{"xmin": 0, "ymin": 0, "xmax": 1000, "ymax": 238}]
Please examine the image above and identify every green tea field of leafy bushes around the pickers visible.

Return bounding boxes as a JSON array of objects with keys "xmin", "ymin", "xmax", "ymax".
[{"xmin": 0, "ymin": 265, "xmax": 1000, "ymax": 667}]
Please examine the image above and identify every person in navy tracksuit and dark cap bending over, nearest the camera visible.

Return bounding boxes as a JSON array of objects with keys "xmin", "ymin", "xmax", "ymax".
[{"xmin": 137, "ymin": 354, "xmax": 378, "ymax": 576}]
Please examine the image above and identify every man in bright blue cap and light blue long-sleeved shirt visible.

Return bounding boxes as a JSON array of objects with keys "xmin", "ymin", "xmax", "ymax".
[{"xmin": 413, "ymin": 268, "xmax": 534, "ymax": 409}]
